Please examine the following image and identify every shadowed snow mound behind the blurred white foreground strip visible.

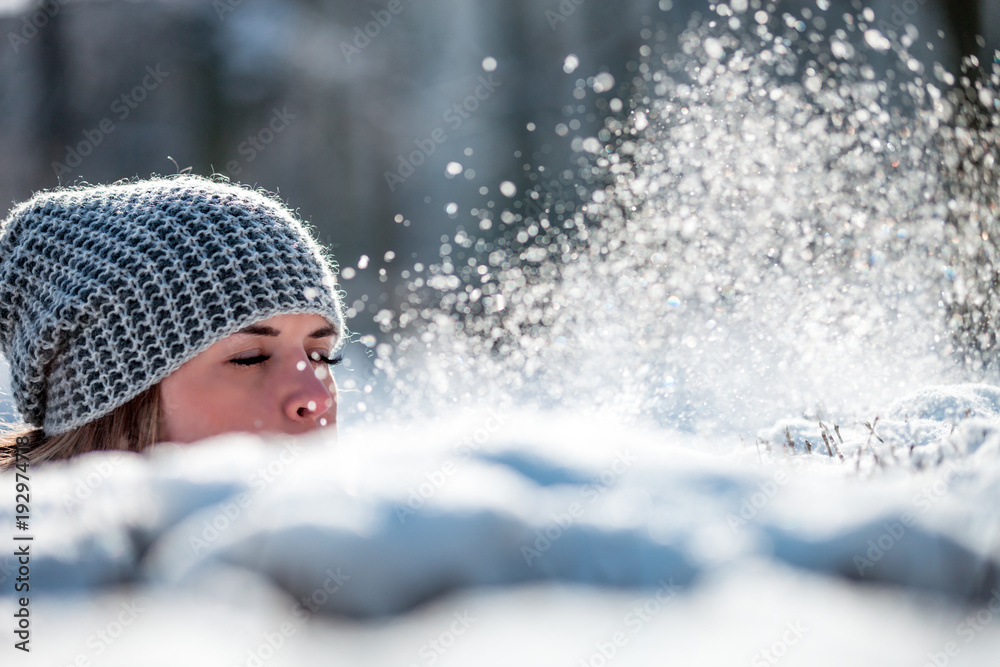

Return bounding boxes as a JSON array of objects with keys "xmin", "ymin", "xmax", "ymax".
[{"xmin": 0, "ymin": 386, "xmax": 1000, "ymax": 617}]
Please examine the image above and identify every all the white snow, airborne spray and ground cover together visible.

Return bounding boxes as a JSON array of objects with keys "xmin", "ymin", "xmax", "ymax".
[{"xmin": 0, "ymin": 2, "xmax": 1000, "ymax": 667}]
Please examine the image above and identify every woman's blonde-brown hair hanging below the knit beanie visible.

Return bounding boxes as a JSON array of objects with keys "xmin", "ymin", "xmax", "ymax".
[{"xmin": 0, "ymin": 384, "xmax": 162, "ymax": 471}]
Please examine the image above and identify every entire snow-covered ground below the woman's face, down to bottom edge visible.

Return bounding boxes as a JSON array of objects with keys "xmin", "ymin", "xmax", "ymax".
[{"xmin": 0, "ymin": 385, "xmax": 1000, "ymax": 667}]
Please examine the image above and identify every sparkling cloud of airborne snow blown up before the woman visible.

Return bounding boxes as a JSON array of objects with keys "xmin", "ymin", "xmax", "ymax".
[{"xmin": 377, "ymin": 0, "xmax": 1000, "ymax": 431}]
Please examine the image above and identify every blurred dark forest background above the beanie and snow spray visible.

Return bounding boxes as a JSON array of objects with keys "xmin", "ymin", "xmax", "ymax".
[{"xmin": 0, "ymin": 0, "xmax": 1000, "ymax": 420}]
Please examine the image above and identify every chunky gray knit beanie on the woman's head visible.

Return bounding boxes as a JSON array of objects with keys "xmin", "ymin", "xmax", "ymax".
[{"xmin": 0, "ymin": 175, "xmax": 344, "ymax": 435}]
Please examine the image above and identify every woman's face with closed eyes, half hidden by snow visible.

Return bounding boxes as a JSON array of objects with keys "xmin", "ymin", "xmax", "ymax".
[{"xmin": 160, "ymin": 314, "xmax": 337, "ymax": 443}]
